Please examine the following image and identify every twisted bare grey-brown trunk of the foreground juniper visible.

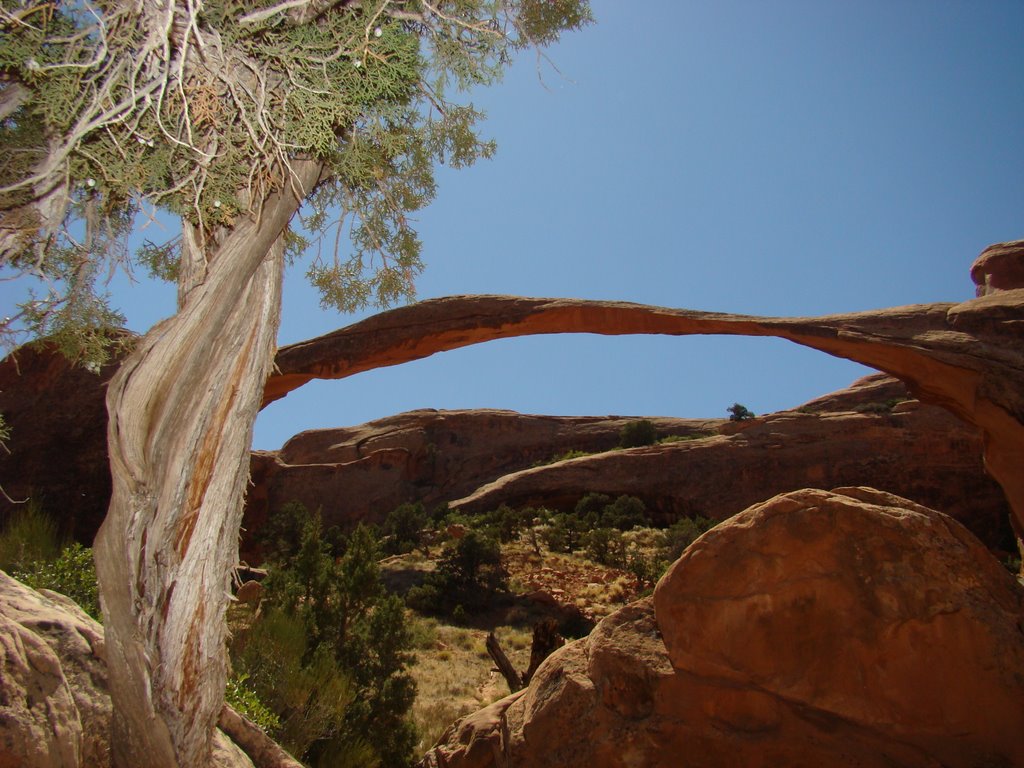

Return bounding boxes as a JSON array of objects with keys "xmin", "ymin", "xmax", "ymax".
[{"xmin": 95, "ymin": 162, "xmax": 321, "ymax": 768}]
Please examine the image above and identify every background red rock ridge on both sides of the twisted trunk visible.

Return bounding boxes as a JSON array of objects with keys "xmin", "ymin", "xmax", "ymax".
[{"xmin": 0, "ymin": 348, "xmax": 1013, "ymax": 559}]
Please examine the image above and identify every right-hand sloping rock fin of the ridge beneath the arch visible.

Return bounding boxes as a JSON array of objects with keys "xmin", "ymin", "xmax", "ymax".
[{"xmin": 451, "ymin": 393, "xmax": 1014, "ymax": 551}]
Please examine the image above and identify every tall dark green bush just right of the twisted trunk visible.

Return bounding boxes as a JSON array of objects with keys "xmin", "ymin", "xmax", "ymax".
[{"xmin": 244, "ymin": 506, "xmax": 416, "ymax": 766}]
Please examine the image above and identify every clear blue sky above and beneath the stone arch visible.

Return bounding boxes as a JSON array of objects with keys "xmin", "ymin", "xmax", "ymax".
[{"xmin": 2, "ymin": 0, "xmax": 1024, "ymax": 449}]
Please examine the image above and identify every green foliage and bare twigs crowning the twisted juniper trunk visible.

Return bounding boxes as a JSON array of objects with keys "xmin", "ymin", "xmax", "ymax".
[{"xmin": 0, "ymin": 0, "xmax": 591, "ymax": 359}]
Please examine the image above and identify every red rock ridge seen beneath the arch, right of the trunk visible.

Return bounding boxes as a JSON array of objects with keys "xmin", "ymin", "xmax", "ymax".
[{"xmin": 245, "ymin": 374, "xmax": 1012, "ymax": 548}]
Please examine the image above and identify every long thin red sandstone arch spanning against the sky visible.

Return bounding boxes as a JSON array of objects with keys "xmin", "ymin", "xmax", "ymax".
[{"xmin": 263, "ymin": 288, "xmax": 1024, "ymax": 535}]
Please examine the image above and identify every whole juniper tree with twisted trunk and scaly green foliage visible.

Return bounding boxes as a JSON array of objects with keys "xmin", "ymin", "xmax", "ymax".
[{"xmin": 0, "ymin": 0, "xmax": 589, "ymax": 767}]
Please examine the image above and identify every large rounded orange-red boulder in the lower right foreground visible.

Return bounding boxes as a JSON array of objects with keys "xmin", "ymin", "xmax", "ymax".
[{"xmin": 421, "ymin": 487, "xmax": 1024, "ymax": 768}]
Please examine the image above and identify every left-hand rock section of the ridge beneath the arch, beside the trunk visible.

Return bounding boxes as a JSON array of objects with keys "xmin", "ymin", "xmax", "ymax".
[{"xmin": 244, "ymin": 410, "xmax": 723, "ymax": 548}]
